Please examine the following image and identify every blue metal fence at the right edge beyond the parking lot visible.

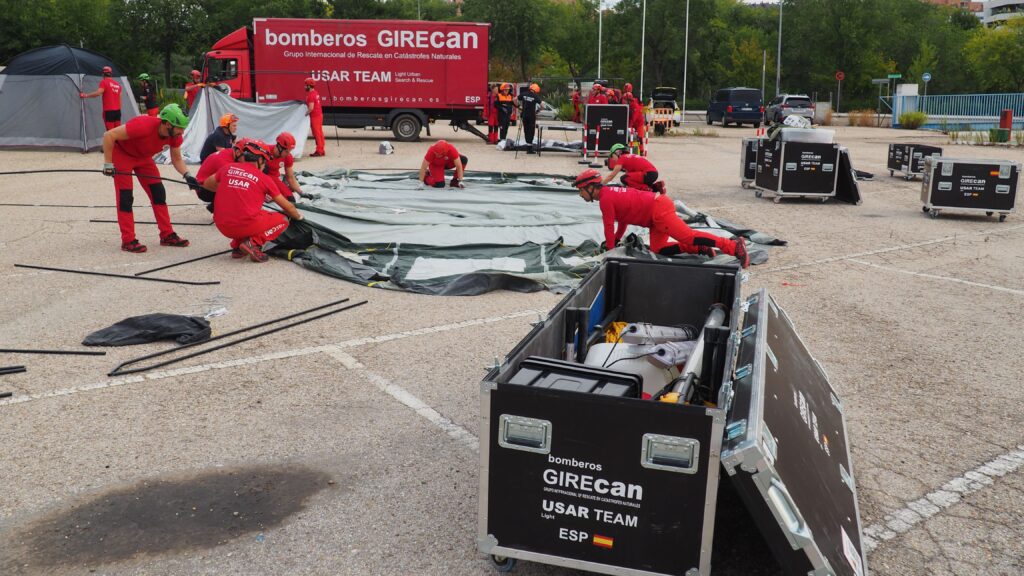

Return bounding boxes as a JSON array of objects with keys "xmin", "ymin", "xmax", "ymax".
[{"xmin": 886, "ymin": 93, "xmax": 1024, "ymax": 129}]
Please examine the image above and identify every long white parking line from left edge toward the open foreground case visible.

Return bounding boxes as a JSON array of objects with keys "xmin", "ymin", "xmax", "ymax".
[{"xmin": 0, "ymin": 310, "xmax": 538, "ymax": 407}]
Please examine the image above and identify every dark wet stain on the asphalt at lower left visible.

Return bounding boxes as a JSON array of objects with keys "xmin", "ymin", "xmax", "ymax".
[{"xmin": 0, "ymin": 466, "xmax": 334, "ymax": 574}]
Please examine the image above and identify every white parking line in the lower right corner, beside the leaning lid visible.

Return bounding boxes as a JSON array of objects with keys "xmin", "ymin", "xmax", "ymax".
[{"xmin": 863, "ymin": 444, "xmax": 1024, "ymax": 552}]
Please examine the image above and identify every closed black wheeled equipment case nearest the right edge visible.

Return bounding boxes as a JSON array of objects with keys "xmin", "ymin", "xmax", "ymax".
[{"xmin": 921, "ymin": 157, "xmax": 1021, "ymax": 222}]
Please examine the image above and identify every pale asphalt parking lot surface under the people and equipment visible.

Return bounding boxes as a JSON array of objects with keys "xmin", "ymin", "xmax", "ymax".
[{"xmin": 0, "ymin": 118, "xmax": 1024, "ymax": 576}]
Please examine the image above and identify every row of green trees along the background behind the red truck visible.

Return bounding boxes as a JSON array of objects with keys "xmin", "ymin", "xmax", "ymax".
[{"xmin": 0, "ymin": 0, "xmax": 1024, "ymax": 110}]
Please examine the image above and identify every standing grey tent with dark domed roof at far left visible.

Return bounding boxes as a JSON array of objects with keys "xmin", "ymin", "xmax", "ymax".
[{"xmin": 0, "ymin": 44, "xmax": 138, "ymax": 152}]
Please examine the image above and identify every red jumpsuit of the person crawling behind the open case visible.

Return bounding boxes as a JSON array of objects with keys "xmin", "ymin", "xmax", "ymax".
[{"xmin": 600, "ymin": 187, "xmax": 736, "ymax": 255}]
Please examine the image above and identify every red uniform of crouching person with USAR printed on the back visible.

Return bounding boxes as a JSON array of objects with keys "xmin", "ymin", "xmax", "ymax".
[{"xmin": 213, "ymin": 162, "xmax": 288, "ymax": 249}]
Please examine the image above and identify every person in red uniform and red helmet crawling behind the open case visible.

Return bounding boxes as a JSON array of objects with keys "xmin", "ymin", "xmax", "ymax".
[{"xmin": 572, "ymin": 169, "xmax": 751, "ymax": 268}]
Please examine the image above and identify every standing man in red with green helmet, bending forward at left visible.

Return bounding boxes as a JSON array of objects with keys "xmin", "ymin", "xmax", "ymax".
[{"xmin": 103, "ymin": 104, "xmax": 193, "ymax": 253}]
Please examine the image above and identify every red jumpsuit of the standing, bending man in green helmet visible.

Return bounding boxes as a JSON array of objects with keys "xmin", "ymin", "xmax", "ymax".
[{"xmin": 113, "ymin": 116, "xmax": 181, "ymax": 244}]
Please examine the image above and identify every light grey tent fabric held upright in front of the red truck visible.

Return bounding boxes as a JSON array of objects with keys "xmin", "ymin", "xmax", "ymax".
[{"xmin": 156, "ymin": 87, "xmax": 309, "ymax": 164}]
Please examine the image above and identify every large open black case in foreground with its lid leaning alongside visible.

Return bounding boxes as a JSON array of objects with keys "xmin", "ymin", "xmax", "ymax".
[{"xmin": 477, "ymin": 258, "xmax": 867, "ymax": 576}]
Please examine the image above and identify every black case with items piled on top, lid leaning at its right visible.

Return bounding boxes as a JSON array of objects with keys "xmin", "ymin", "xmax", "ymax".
[{"xmin": 754, "ymin": 139, "xmax": 840, "ymax": 204}]
